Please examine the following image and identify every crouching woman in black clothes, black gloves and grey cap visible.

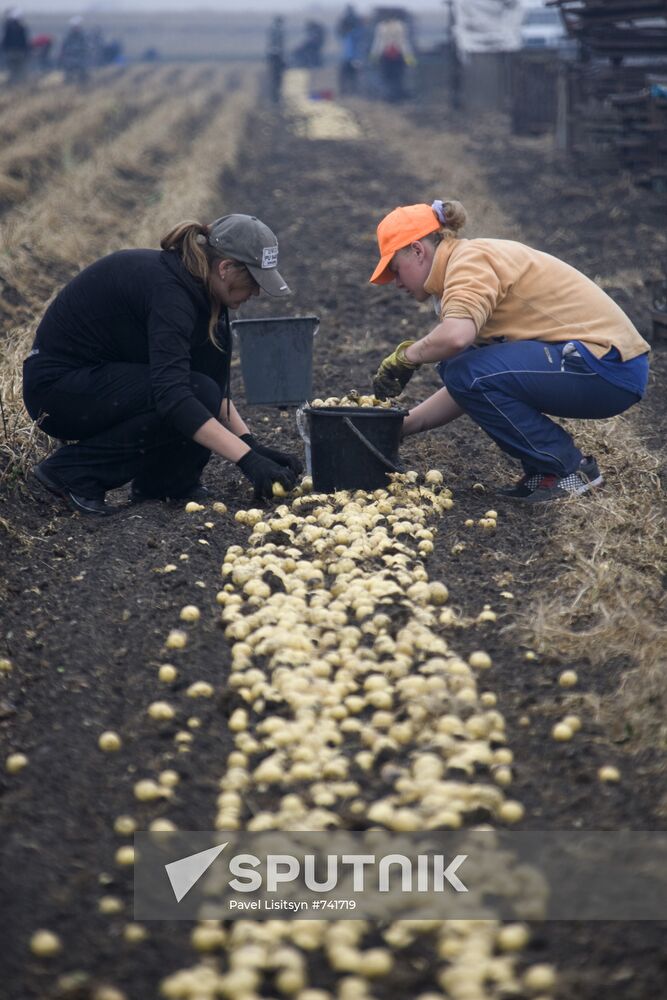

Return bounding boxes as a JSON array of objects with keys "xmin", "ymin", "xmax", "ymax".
[{"xmin": 23, "ymin": 215, "xmax": 301, "ymax": 515}]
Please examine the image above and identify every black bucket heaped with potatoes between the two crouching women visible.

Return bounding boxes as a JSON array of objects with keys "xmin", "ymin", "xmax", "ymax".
[{"xmin": 303, "ymin": 406, "xmax": 407, "ymax": 493}]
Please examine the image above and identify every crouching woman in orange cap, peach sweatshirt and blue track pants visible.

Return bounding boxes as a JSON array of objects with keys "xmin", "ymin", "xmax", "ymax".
[{"xmin": 370, "ymin": 201, "xmax": 650, "ymax": 502}]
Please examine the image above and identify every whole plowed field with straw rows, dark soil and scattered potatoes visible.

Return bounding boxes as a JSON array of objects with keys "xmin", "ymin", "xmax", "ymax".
[{"xmin": 0, "ymin": 66, "xmax": 667, "ymax": 1000}]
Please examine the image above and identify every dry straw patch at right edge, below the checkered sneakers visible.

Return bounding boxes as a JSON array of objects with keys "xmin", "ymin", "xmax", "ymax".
[{"xmin": 523, "ymin": 417, "xmax": 667, "ymax": 747}]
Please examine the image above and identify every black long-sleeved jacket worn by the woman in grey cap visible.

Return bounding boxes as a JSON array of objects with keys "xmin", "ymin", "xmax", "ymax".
[{"xmin": 33, "ymin": 250, "xmax": 231, "ymax": 437}]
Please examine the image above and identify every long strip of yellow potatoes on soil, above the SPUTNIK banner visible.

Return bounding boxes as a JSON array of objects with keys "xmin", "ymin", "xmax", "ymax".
[{"xmin": 216, "ymin": 470, "xmax": 523, "ymax": 832}]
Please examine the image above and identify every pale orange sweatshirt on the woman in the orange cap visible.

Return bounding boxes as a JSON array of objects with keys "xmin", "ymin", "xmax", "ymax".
[{"xmin": 424, "ymin": 239, "xmax": 651, "ymax": 361}]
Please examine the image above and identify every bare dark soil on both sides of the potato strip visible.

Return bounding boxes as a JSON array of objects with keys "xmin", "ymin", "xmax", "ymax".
[{"xmin": 0, "ymin": 90, "xmax": 667, "ymax": 1000}]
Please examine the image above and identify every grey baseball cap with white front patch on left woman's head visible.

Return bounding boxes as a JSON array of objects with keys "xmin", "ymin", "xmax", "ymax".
[{"xmin": 208, "ymin": 214, "xmax": 290, "ymax": 296}]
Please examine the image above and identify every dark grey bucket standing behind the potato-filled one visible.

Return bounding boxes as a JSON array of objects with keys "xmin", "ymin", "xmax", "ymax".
[{"xmin": 232, "ymin": 316, "xmax": 320, "ymax": 406}]
